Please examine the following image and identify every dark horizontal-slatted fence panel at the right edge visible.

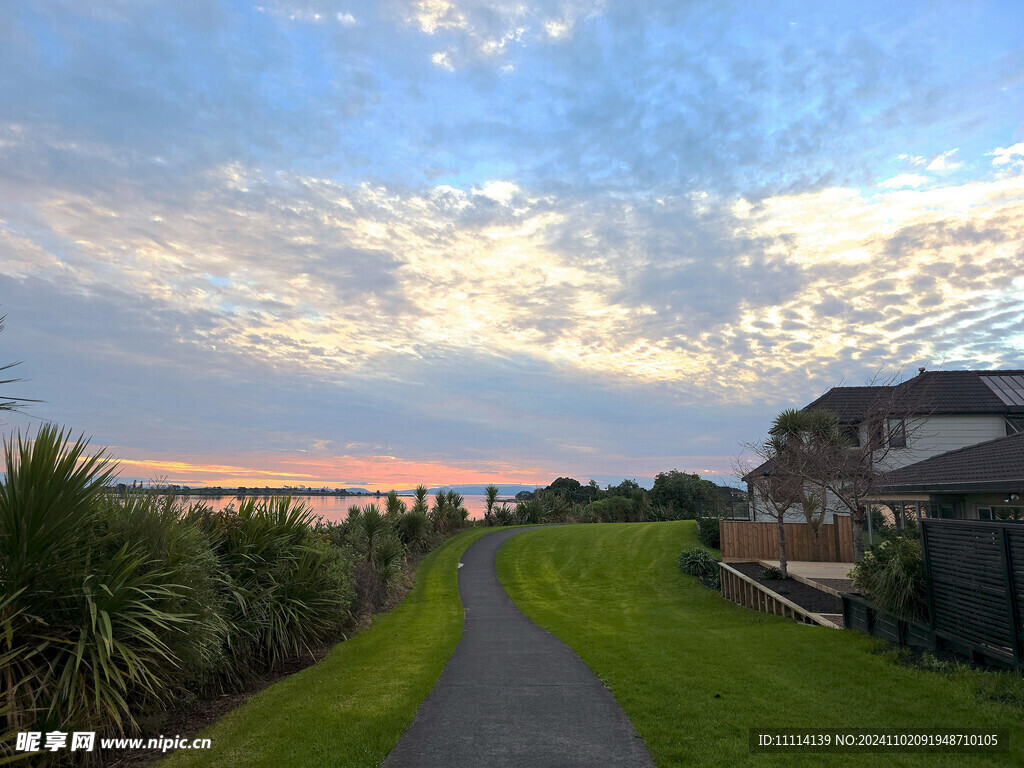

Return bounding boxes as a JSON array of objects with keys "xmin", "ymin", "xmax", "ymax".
[{"xmin": 922, "ymin": 519, "xmax": 1024, "ymax": 667}]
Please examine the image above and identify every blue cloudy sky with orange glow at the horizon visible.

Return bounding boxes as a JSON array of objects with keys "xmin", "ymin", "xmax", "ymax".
[{"xmin": 0, "ymin": 0, "xmax": 1024, "ymax": 489}]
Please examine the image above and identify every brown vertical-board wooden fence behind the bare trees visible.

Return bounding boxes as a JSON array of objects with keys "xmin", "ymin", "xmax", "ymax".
[{"xmin": 718, "ymin": 515, "xmax": 853, "ymax": 562}]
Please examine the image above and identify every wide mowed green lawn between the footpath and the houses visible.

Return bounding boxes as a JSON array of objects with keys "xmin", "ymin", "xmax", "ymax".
[{"xmin": 498, "ymin": 521, "xmax": 1024, "ymax": 768}]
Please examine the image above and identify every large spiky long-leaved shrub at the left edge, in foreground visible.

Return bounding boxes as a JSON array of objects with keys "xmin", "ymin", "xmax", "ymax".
[{"xmin": 0, "ymin": 426, "xmax": 195, "ymax": 750}]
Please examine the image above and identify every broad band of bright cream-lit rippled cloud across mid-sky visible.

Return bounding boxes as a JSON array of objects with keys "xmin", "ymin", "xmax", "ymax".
[{"xmin": 8, "ymin": 136, "xmax": 1024, "ymax": 415}]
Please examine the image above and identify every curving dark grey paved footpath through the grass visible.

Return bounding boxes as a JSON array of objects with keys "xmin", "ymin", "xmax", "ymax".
[{"xmin": 384, "ymin": 528, "xmax": 654, "ymax": 768}]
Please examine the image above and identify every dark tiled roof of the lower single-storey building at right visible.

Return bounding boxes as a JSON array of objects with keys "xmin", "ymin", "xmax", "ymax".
[{"xmin": 880, "ymin": 432, "xmax": 1024, "ymax": 492}]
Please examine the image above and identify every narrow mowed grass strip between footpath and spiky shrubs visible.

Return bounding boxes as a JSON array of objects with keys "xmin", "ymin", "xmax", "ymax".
[{"xmin": 161, "ymin": 528, "xmax": 499, "ymax": 768}]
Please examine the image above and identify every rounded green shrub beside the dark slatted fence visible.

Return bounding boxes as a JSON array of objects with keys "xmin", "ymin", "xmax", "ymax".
[{"xmin": 850, "ymin": 531, "xmax": 928, "ymax": 618}]
